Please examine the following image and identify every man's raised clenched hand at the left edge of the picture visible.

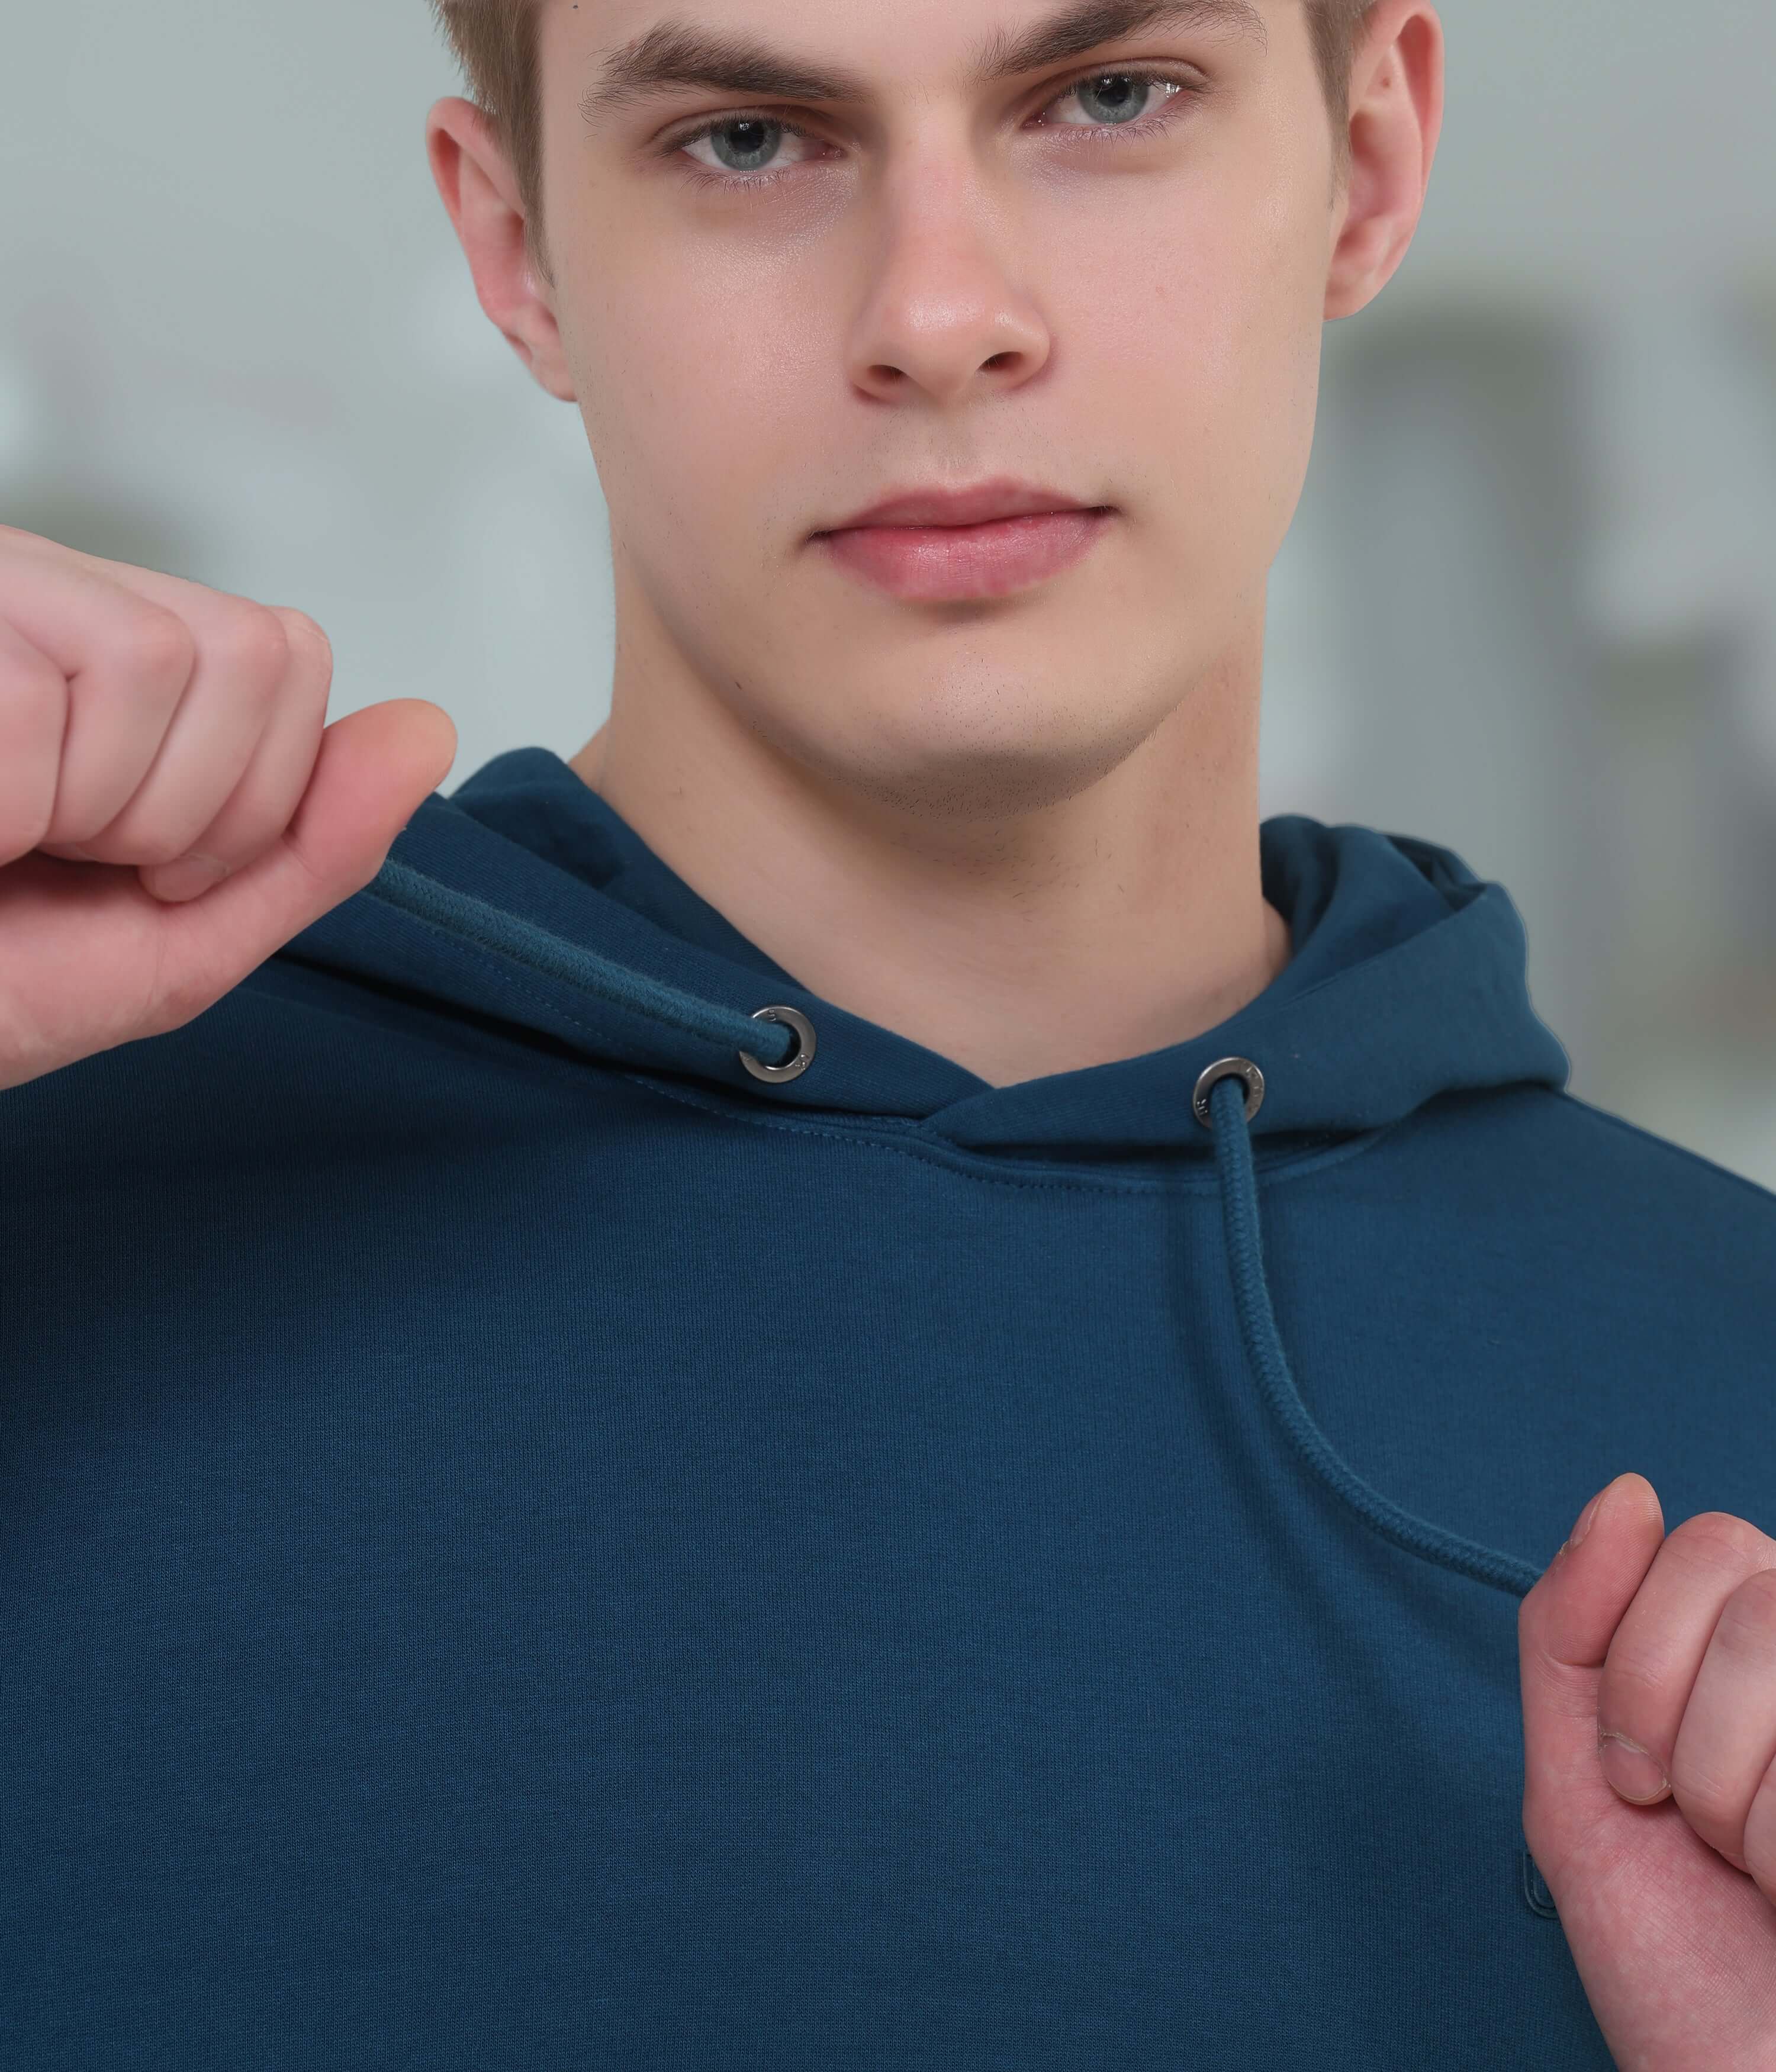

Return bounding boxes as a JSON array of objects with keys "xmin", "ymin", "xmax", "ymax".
[{"xmin": 0, "ymin": 526, "xmax": 456, "ymax": 1088}]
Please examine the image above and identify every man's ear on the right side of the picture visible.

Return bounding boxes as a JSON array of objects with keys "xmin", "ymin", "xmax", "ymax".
[{"xmin": 1326, "ymin": 0, "xmax": 1442, "ymax": 319}]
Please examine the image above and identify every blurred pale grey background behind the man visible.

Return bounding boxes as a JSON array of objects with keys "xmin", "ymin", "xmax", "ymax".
[{"xmin": 0, "ymin": 0, "xmax": 1776, "ymax": 1188}]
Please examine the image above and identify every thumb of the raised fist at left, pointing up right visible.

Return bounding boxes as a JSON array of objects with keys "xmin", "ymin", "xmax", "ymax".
[{"xmin": 166, "ymin": 699, "xmax": 456, "ymax": 997}]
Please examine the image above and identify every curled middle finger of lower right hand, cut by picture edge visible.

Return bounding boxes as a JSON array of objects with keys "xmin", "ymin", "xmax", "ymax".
[{"xmin": 1670, "ymin": 1569, "xmax": 1776, "ymax": 1890}]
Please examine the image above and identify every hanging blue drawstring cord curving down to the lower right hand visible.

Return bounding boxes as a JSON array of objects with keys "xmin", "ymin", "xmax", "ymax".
[{"xmin": 1206, "ymin": 1067, "xmax": 1542, "ymax": 1598}]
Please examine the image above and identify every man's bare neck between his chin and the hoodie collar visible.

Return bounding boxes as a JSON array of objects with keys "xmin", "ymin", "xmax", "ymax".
[{"xmin": 570, "ymin": 617, "xmax": 1289, "ymax": 1086}]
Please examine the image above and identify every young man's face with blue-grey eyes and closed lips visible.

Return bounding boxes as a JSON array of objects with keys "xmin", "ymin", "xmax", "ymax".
[{"xmin": 541, "ymin": 0, "xmax": 1337, "ymax": 815}]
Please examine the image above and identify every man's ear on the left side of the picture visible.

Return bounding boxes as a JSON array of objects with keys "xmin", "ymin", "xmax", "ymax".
[{"xmin": 425, "ymin": 95, "xmax": 576, "ymax": 402}]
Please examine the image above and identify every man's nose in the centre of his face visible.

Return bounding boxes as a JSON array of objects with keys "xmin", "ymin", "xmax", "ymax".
[{"xmin": 833, "ymin": 145, "xmax": 1051, "ymax": 406}]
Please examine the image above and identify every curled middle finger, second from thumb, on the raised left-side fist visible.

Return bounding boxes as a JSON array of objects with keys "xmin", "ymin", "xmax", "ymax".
[{"xmin": 81, "ymin": 595, "xmax": 290, "ymax": 864}]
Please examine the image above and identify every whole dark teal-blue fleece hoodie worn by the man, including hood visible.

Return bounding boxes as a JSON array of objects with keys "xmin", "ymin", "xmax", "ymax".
[{"xmin": 0, "ymin": 748, "xmax": 1776, "ymax": 2072}]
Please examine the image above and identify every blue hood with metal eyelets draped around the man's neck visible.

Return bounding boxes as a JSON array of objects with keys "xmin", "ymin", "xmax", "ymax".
[{"xmin": 280, "ymin": 748, "xmax": 1569, "ymax": 1159}]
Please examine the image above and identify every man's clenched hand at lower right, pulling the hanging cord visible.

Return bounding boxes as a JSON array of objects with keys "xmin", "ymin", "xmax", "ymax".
[{"xmin": 1517, "ymin": 1475, "xmax": 1776, "ymax": 2072}]
